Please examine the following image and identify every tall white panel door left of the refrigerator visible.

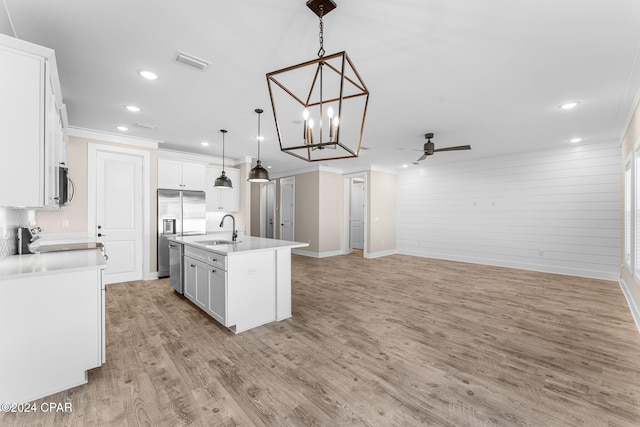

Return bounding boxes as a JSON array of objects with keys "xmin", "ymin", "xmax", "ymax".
[{"xmin": 95, "ymin": 151, "xmax": 143, "ymax": 284}]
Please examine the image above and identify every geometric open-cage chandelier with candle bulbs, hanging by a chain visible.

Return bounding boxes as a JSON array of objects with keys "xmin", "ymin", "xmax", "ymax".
[{"xmin": 267, "ymin": 0, "xmax": 369, "ymax": 162}]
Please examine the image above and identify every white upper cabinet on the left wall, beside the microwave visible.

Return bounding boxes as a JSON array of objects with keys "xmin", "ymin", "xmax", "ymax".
[{"xmin": 0, "ymin": 34, "xmax": 67, "ymax": 209}]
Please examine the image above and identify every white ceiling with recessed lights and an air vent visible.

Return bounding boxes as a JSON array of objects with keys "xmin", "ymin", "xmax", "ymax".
[{"xmin": 0, "ymin": 0, "xmax": 640, "ymax": 174}]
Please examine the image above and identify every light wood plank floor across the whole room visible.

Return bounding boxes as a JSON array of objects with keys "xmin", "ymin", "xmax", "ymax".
[{"xmin": 0, "ymin": 255, "xmax": 640, "ymax": 426}]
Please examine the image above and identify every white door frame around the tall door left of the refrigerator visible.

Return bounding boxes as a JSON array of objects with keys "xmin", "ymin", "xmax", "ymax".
[{"xmin": 87, "ymin": 143, "xmax": 152, "ymax": 280}]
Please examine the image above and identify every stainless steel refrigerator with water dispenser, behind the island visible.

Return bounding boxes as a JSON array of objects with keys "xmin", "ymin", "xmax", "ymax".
[{"xmin": 158, "ymin": 190, "xmax": 207, "ymax": 277}]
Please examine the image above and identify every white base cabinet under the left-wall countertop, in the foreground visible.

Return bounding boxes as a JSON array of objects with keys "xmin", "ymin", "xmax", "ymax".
[{"xmin": 0, "ymin": 268, "xmax": 105, "ymax": 402}]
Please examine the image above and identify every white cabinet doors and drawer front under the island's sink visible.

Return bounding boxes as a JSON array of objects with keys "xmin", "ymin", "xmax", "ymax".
[{"xmin": 184, "ymin": 250, "xmax": 229, "ymax": 326}]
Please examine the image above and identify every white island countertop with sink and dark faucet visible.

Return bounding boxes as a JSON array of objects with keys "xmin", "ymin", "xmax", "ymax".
[{"xmin": 169, "ymin": 233, "xmax": 309, "ymax": 255}]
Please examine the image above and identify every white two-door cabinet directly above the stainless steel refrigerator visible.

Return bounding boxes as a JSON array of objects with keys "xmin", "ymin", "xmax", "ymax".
[{"xmin": 158, "ymin": 158, "xmax": 206, "ymax": 191}]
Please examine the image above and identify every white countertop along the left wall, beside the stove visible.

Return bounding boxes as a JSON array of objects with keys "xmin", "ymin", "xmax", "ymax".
[{"xmin": 0, "ymin": 249, "xmax": 107, "ymax": 281}]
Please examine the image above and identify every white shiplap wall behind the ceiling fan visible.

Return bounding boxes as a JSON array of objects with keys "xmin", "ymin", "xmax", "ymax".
[{"xmin": 397, "ymin": 143, "xmax": 621, "ymax": 280}]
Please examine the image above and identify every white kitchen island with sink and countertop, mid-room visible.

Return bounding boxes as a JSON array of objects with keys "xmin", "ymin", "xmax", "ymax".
[{"xmin": 169, "ymin": 233, "xmax": 308, "ymax": 334}]
